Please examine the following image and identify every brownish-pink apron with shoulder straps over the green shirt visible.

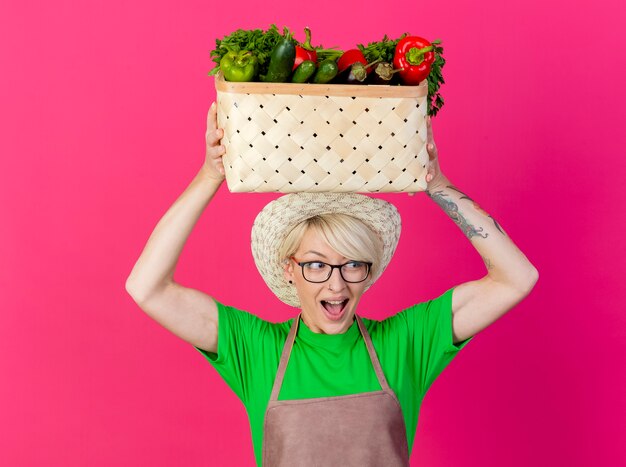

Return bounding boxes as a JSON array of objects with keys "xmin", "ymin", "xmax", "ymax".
[{"xmin": 263, "ymin": 315, "xmax": 409, "ymax": 467}]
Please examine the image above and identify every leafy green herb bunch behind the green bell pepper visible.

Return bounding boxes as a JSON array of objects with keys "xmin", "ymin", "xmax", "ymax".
[{"xmin": 209, "ymin": 24, "xmax": 293, "ymax": 76}]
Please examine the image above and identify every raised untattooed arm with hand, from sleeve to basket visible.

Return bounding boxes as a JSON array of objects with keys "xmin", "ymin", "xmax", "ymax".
[{"xmin": 126, "ymin": 104, "xmax": 224, "ymax": 352}]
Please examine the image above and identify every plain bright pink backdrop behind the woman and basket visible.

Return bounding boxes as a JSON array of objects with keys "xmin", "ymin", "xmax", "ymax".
[{"xmin": 0, "ymin": 0, "xmax": 626, "ymax": 467}]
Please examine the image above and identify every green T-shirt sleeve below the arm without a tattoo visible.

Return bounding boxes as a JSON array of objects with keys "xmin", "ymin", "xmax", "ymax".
[{"xmin": 195, "ymin": 300, "xmax": 269, "ymax": 404}]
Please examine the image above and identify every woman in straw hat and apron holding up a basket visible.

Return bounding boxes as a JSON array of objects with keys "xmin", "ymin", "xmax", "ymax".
[{"xmin": 126, "ymin": 104, "xmax": 538, "ymax": 466}]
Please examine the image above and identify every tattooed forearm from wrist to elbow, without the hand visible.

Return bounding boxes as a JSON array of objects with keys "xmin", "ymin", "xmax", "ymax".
[{"xmin": 426, "ymin": 179, "xmax": 538, "ymax": 290}]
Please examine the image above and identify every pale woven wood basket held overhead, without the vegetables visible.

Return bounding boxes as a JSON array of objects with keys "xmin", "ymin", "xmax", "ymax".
[{"xmin": 215, "ymin": 73, "xmax": 428, "ymax": 193}]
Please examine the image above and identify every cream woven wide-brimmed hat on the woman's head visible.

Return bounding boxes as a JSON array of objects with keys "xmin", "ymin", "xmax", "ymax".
[{"xmin": 252, "ymin": 193, "xmax": 401, "ymax": 307}]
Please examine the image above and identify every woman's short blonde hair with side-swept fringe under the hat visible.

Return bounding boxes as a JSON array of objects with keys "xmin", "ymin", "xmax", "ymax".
[{"xmin": 278, "ymin": 213, "xmax": 383, "ymax": 280}]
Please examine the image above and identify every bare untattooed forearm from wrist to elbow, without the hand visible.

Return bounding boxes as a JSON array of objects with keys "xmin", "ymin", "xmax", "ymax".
[{"xmin": 126, "ymin": 166, "xmax": 221, "ymax": 298}]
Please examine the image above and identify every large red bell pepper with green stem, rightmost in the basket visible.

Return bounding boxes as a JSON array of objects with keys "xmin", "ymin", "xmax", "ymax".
[{"xmin": 393, "ymin": 36, "xmax": 435, "ymax": 85}]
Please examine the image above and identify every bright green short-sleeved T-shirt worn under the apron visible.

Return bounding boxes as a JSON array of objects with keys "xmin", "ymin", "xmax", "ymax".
[{"xmin": 195, "ymin": 288, "xmax": 473, "ymax": 465}]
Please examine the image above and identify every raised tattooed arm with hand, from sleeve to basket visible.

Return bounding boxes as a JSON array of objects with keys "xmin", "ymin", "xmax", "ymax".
[{"xmin": 426, "ymin": 119, "xmax": 539, "ymax": 343}]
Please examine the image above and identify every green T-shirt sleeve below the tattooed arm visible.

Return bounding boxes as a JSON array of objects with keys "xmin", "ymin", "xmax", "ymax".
[{"xmin": 400, "ymin": 288, "xmax": 473, "ymax": 397}]
